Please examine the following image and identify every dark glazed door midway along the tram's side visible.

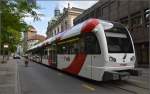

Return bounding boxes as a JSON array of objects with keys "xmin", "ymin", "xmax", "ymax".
[{"xmin": 49, "ymin": 43, "xmax": 57, "ymax": 67}]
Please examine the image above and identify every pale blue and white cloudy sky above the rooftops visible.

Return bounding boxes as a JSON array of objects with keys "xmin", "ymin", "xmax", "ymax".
[{"xmin": 24, "ymin": 0, "xmax": 97, "ymax": 36}]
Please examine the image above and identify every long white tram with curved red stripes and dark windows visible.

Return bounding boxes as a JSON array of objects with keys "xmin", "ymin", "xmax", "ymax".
[{"xmin": 28, "ymin": 18, "xmax": 136, "ymax": 81}]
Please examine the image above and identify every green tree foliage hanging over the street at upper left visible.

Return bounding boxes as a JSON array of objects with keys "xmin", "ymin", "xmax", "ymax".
[{"xmin": 0, "ymin": 0, "xmax": 39, "ymax": 52}]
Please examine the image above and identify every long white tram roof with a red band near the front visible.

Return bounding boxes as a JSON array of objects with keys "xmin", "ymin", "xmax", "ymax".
[{"xmin": 27, "ymin": 18, "xmax": 113, "ymax": 51}]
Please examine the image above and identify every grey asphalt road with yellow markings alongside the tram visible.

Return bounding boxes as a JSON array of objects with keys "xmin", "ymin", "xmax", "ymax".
[{"xmin": 18, "ymin": 60, "xmax": 147, "ymax": 94}]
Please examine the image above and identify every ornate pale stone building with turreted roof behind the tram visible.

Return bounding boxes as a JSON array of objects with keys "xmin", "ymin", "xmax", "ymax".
[{"xmin": 46, "ymin": 4, "xmax": 84, "ymax": 38}]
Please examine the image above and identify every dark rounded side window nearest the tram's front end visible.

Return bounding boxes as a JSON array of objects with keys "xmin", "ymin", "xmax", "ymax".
[{"xmin": 83, "ymin": 32, "xmax": 101, "ymax": 54}]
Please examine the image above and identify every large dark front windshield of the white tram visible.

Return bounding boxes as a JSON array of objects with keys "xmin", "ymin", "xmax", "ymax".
[{"xmin": 105, "ymin": 25, "xmax": 133, "ymax": 53}]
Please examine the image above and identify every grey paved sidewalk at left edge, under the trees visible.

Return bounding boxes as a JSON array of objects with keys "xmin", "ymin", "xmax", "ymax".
[{"xmin": 0, "ymin": 56, "xmax": 19, "ymax": 94}]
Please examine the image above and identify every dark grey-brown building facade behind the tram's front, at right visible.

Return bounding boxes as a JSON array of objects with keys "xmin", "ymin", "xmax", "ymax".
[{"xmin": 74, "ymin": 0, "xmax": 150, "ymax": 67}]
